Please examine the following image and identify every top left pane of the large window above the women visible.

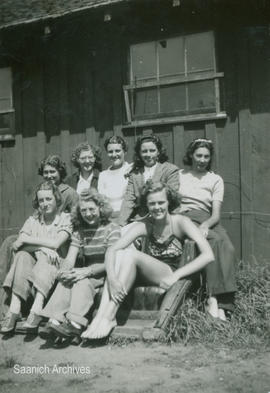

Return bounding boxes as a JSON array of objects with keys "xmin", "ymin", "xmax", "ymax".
[{"xmin": 131, "ymin": 42, "xmax": 157, "ymax": 81}]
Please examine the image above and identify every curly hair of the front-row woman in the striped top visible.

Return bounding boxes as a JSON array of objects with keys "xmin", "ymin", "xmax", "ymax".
[{"xmin": 71, "ymin": 188, "xmax": 113, "ymax": 230}]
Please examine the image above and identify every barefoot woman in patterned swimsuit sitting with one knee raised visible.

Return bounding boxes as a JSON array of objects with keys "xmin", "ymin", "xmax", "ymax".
[{"xmin": 82, "ymin": 181, "xmax": 214, "ymax": 339}]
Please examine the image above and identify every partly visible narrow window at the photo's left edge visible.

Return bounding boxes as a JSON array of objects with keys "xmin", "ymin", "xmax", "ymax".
[{"xmin": 0, "ymin": 67, "xmax": 14, "ymax": 141}]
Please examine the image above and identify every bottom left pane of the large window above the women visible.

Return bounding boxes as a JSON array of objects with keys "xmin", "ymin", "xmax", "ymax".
[{"xmin": 134, "ymin": 88, "xmax": 158, "ymax": 116}]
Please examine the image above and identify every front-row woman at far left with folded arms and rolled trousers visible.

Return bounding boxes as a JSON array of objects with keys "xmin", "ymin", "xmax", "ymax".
[{"xmin": 0, "ymin": 181, "xmax": 72, "ymax": 334}]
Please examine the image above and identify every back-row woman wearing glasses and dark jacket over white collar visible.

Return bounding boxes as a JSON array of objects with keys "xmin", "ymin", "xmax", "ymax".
[{"xmin": 66, "ymin": 142, "xmax": 101, "ymax": 194}]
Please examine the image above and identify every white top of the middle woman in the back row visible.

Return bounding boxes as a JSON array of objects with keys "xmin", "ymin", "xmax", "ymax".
[{"xmin": 98, "ymin": 162, "xmax": 131, "ymax": 212}]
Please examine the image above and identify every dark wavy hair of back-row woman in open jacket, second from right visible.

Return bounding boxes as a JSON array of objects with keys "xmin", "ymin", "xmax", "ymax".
[{"xmin": 131, "ymin": 135, "xmax": 168, "ymax": 172}]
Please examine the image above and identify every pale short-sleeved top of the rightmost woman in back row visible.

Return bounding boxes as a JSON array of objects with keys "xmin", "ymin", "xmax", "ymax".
[{"xmin": 179, "ymin": 169, "xmax": 224, "ymax": 213}]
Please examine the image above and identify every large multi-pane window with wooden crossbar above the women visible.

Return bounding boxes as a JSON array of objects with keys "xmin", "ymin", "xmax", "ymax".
[{"xmin": 124, "ymin": 31, "xmax": 224, "ymax": 123}]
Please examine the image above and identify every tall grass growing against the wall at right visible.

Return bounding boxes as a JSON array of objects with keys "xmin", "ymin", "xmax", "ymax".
[{"xmin": 167, "ymin": 262, "xmax": 270, "ymax": 347}]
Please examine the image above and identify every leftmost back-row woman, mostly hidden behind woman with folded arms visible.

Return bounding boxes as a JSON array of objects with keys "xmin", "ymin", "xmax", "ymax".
[{"xmin": 0, "ymin": 155, "xmax": 78, "ymax": 286}]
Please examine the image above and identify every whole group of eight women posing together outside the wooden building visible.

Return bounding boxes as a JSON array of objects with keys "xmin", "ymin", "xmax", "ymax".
[{"xmin": 0, "ymin": 135, "xmax": 236, "ymax": 339}]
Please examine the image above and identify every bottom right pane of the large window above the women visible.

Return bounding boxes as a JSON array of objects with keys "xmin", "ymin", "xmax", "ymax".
[{"xmin": 188, "ymin": 80, "xmax": 215, "ymax": 111}]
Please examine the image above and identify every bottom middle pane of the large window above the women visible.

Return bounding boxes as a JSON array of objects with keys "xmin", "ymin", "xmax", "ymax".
[{"xmin": 160, "ymin": 85, "xmax": 186, "ymax": 113}]
